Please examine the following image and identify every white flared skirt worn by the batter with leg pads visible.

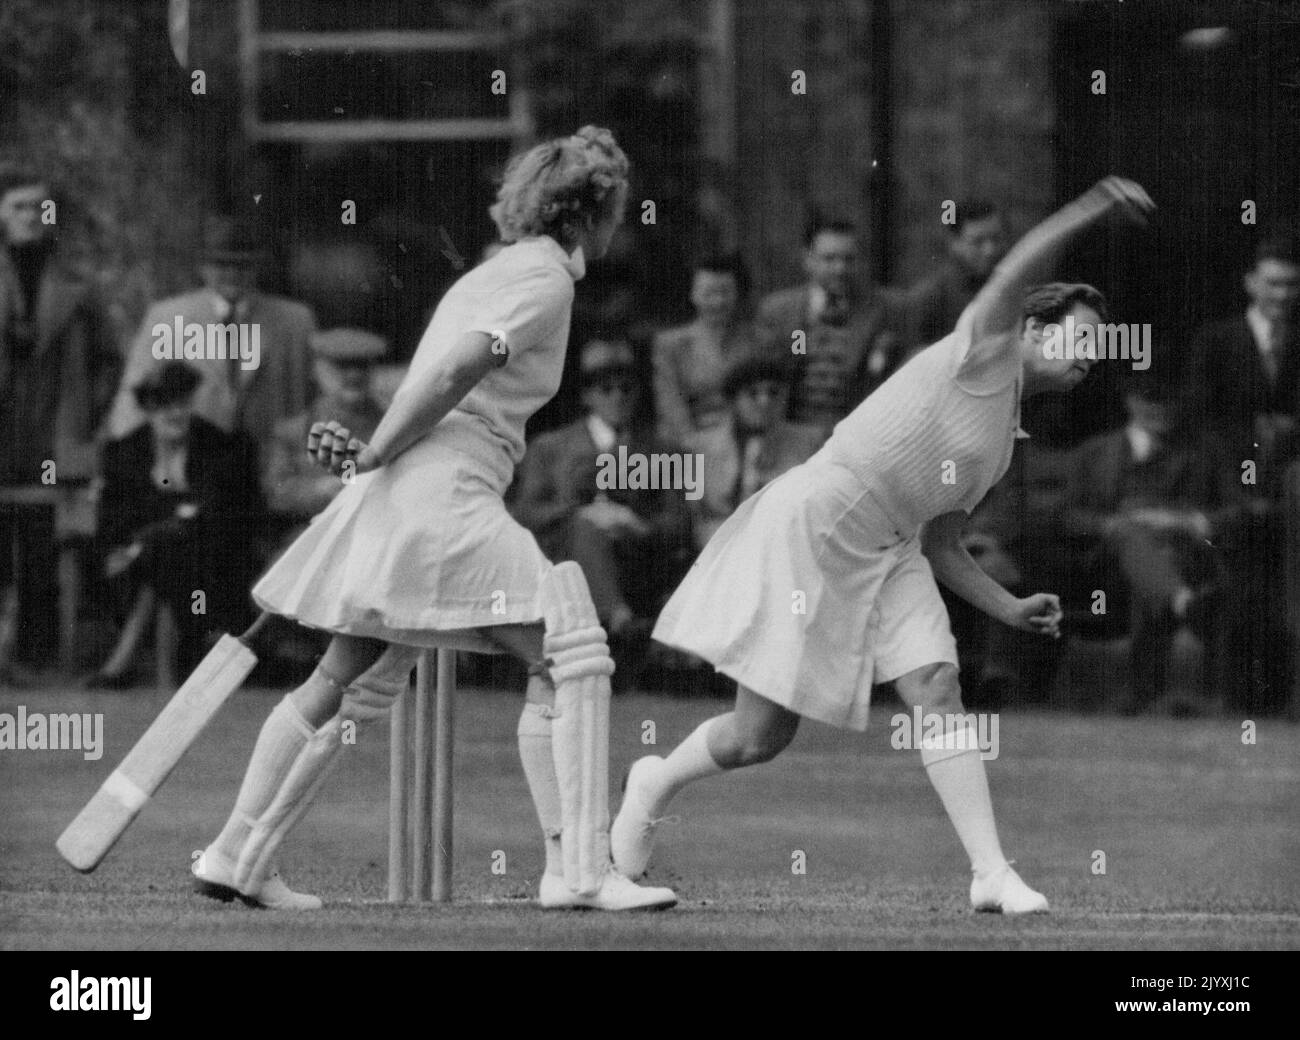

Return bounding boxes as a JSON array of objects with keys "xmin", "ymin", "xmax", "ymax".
[{"xmin": 252, "ymin": 425, "xmax": 551, "ymax": 653}]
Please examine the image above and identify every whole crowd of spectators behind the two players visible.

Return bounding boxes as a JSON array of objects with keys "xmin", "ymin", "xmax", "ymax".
[{"xmin": 0, "ymin": 162, "xmax": 1300, "ymax": 711}]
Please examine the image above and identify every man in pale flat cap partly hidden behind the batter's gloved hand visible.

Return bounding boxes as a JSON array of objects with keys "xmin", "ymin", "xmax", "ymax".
[{"xmin": 264, "ymin": 329, "xmax": 387, "ymax": 527}]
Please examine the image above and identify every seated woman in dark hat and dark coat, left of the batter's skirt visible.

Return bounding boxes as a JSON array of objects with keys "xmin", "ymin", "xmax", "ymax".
[{"xmin": 98, "ymin": 361, "xmax": 264, "ymax": 685}]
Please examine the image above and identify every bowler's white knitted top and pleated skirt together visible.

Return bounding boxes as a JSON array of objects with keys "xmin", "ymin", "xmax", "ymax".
[{"xmin": 654, "ymin": 309, "xmax": 1021, "ymax": 729}]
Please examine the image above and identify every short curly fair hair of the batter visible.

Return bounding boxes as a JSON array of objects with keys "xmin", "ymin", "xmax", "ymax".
[{"xmin": 488, "ymin": 126, "xmax": 628, "ymax": 247}]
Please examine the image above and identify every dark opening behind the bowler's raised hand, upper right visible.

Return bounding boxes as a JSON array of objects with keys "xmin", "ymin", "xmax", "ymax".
[{"xmin": 1026, "ymin": 0, "xmax": 1300, "ymax": 439}]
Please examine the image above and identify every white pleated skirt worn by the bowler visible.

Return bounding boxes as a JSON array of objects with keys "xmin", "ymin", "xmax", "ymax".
[{"xmin": 654, "ymin": 451, "xmax": 957, "ymax": 729}]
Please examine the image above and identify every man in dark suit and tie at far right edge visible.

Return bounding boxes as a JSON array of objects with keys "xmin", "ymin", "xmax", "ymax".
[{"xmin": 1188, "ymin": 231, "xmax": 1300, "ymax": 710}]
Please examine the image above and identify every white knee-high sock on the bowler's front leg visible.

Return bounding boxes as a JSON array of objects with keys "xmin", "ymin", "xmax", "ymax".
[{"xmin": 920, "ymin": 723, "xmax": 1006, "ymax": 874}]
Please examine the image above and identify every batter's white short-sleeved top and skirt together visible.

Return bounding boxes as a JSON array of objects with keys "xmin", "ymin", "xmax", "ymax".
[{"xmin": 252, "ymin": 235, "xmax": 584, "ymax": 650}]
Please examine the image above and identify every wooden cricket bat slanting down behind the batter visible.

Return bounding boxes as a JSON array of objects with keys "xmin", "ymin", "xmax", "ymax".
[{"xmin": 55, "ymin": 614, "xmax": 269, "ymax": 874}]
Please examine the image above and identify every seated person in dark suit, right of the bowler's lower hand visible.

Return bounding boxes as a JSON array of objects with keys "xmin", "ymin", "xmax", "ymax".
[{"xmin": 1063, "ymin": 378, "xmax": 1245, "ymax": 711}]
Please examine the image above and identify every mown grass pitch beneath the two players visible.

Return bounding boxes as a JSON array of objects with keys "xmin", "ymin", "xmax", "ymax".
[{"xmin": 0, "ymin": 688, "xmax": 1300, "ymax": 949}]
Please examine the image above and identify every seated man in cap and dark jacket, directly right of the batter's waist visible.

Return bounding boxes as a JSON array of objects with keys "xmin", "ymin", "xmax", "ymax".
[{"xmin": 511, "ymin": 341, "xmax": 690, "ymax": 645}]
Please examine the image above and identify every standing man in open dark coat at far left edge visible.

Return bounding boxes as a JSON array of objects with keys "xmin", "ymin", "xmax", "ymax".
[{"xmin": 0, "ymin": 166, "xmax": 121, "ymax": 664}]
